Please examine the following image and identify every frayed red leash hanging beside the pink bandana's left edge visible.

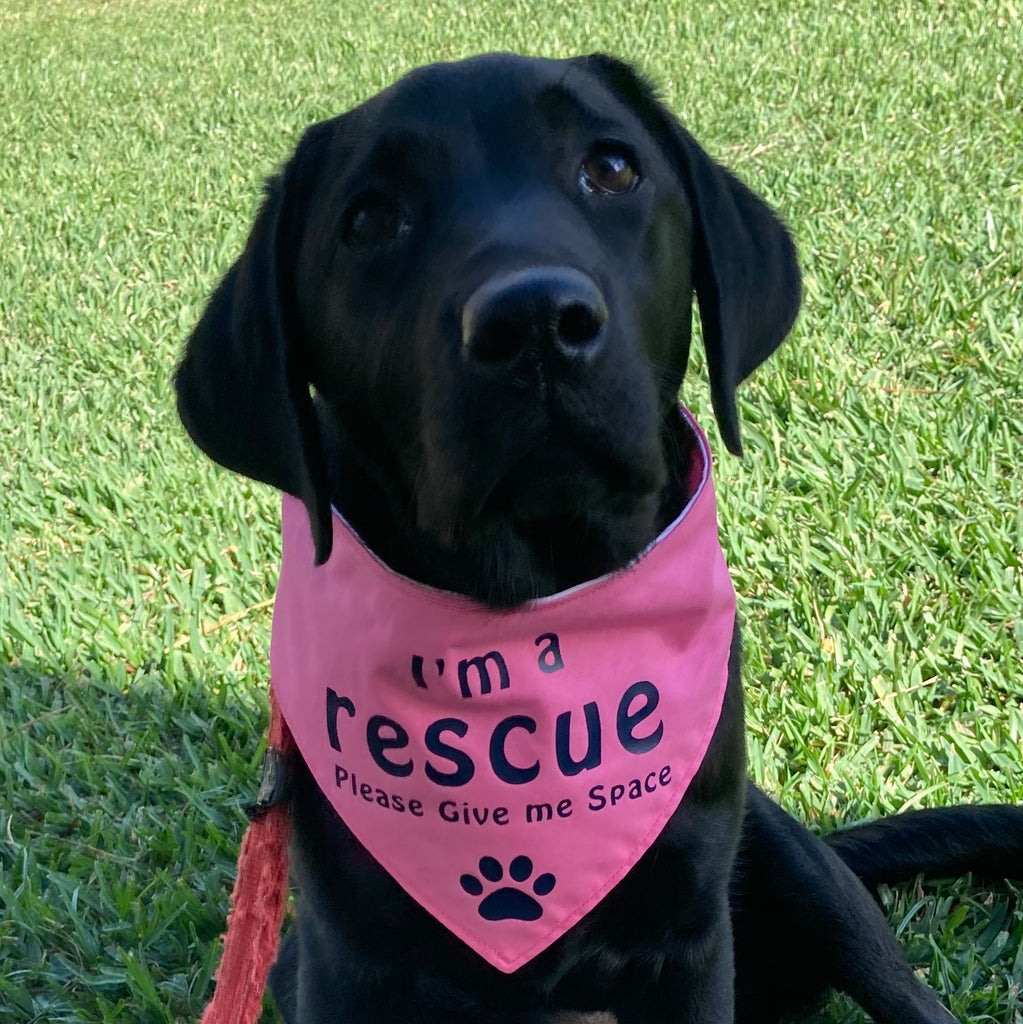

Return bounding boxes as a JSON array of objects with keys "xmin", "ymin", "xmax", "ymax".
[{"xmin": 202, "ymin": 690, "xmax": 295, "ymax": 1024}]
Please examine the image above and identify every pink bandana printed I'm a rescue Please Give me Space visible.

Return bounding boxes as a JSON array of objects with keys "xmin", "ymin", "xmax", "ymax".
[{"xmin": 270, "ymin": 410, "xmax": 735, "ymax": 972}]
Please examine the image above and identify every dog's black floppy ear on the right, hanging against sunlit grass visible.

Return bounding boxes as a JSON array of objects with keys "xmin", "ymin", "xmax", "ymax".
[{"xmin": 583, "ymin": 54, "xmax": 802, "ymax": 455}]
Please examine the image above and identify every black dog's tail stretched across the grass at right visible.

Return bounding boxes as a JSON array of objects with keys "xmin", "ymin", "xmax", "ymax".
[{"xmin": 824, "ymin": 804, "xmax": 1023, "ymax": 888}]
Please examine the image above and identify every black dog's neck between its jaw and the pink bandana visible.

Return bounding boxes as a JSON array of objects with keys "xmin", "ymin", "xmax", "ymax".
[{"xmin": 319, "ymin": 409, "xmax": 695, "ymax": 607}]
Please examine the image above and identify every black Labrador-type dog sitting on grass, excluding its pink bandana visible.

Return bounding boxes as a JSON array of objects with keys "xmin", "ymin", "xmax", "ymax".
[{"xmin": 176, "ymin": 56, "xmax": 1023, "ymax": 1024}]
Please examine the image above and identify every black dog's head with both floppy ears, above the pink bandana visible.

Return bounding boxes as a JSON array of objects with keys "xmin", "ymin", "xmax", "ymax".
[{"xmin": 176, "ymin": 55, "xmax": 800, "ymax": 604}]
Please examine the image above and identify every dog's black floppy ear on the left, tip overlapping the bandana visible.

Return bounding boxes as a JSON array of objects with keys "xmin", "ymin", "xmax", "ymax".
[{"xmin": 174, "ymin": 126, "xmax": 332, "ymax": 564}]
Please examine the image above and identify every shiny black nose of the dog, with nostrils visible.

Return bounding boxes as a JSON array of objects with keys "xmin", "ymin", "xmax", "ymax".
[{"xmin": 462, "ymin": 266, "xmax": 607, "ymax": 369}]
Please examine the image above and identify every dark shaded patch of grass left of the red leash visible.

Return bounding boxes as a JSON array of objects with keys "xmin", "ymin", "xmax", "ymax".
[{"xmin": 0, "ymin": 665, "xmax": 280, "ymax": 1024}]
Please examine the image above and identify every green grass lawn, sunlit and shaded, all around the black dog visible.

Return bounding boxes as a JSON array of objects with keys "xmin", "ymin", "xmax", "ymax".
[{"xmin": 0, "ymin": 0, "xmax": 1023, "ymax": 1024}]
